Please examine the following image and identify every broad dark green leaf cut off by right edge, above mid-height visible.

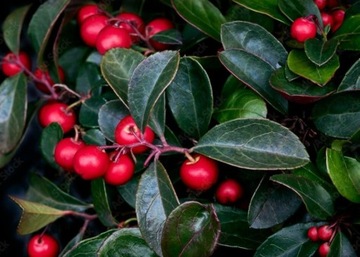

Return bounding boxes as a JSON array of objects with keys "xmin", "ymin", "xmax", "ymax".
[{"xmin": 311, "ymin": 91, "xmax": 360, "ymax": 138}]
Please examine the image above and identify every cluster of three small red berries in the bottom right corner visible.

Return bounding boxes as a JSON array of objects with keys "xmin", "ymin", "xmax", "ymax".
[{"xmin": 307, "ymin": 225, "xmax": 334, "ymax": 257}]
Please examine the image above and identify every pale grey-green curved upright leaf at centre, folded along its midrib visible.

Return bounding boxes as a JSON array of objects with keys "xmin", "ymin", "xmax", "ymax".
[{"xmin": 128, "ymin": 51, "xmax": 180, "ymax": 131}]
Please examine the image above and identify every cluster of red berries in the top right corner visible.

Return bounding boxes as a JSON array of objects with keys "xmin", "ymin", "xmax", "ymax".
[{"xmin": 290, "ymin": 0, "xmax": 345, "ymax": 43}]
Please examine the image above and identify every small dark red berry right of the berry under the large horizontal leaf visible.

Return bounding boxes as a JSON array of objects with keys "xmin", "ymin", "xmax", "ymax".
[{"xmin": 215, "ymin": 179, "xmax": 244, "ymax": 205}]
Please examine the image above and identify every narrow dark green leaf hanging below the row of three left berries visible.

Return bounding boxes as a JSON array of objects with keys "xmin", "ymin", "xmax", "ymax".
[{"xmin": 91, "ymin": 178, "xmax": 117, "ymax": 227}]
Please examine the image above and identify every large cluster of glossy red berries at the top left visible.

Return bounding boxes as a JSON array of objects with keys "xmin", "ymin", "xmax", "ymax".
[{"xmin": 77, "ymin": 4, "xmax": 174, "ymax": 54}]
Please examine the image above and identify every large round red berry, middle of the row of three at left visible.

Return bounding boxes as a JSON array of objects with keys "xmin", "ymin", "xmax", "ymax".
[{"xmin": 74, "ymin": 145, "xmax": 110, "ymax": 180}]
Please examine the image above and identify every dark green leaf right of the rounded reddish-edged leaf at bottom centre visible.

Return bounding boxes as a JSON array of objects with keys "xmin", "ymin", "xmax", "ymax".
[{"xmin": 215, "ymin": 204, "xmax": 270, "ymax": 250}]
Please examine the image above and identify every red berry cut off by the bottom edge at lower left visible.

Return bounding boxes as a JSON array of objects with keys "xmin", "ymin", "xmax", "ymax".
[{"xmin": 27, "ymin": 234, "xmax": 59, "ymax": 257}]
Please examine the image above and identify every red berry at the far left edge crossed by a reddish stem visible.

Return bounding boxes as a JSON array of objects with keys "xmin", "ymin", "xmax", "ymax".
[{"xmin": 1, "ymin": 52, "xmax": 31, "ymax": 77}]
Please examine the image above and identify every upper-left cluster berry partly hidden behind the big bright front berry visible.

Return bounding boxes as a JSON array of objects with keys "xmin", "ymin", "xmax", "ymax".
[{"xmin": 80, "ymin": 14, "xmax": 108, "ymax": 47}]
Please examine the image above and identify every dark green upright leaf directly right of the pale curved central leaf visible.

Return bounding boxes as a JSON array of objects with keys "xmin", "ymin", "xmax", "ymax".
[{"xmin": 166, "ymin": 57, "xmax": 213, "ymax": 138}]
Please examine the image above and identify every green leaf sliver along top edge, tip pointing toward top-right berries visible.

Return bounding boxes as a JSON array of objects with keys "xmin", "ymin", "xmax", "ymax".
[{"xmin": 233, "ymin": 0, "xmax": 290, "ymax": 25}]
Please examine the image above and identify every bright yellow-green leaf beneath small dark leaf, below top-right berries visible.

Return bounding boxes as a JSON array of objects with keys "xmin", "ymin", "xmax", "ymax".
[{"xmin": 287, "ymin": 50, "xmax": 340, "ymax": 86}]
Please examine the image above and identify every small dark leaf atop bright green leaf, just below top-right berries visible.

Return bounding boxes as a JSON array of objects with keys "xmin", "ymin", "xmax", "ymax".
[{"xmin": 305, "ymin": 38, "xmax": 339, "ymax": 66}]
